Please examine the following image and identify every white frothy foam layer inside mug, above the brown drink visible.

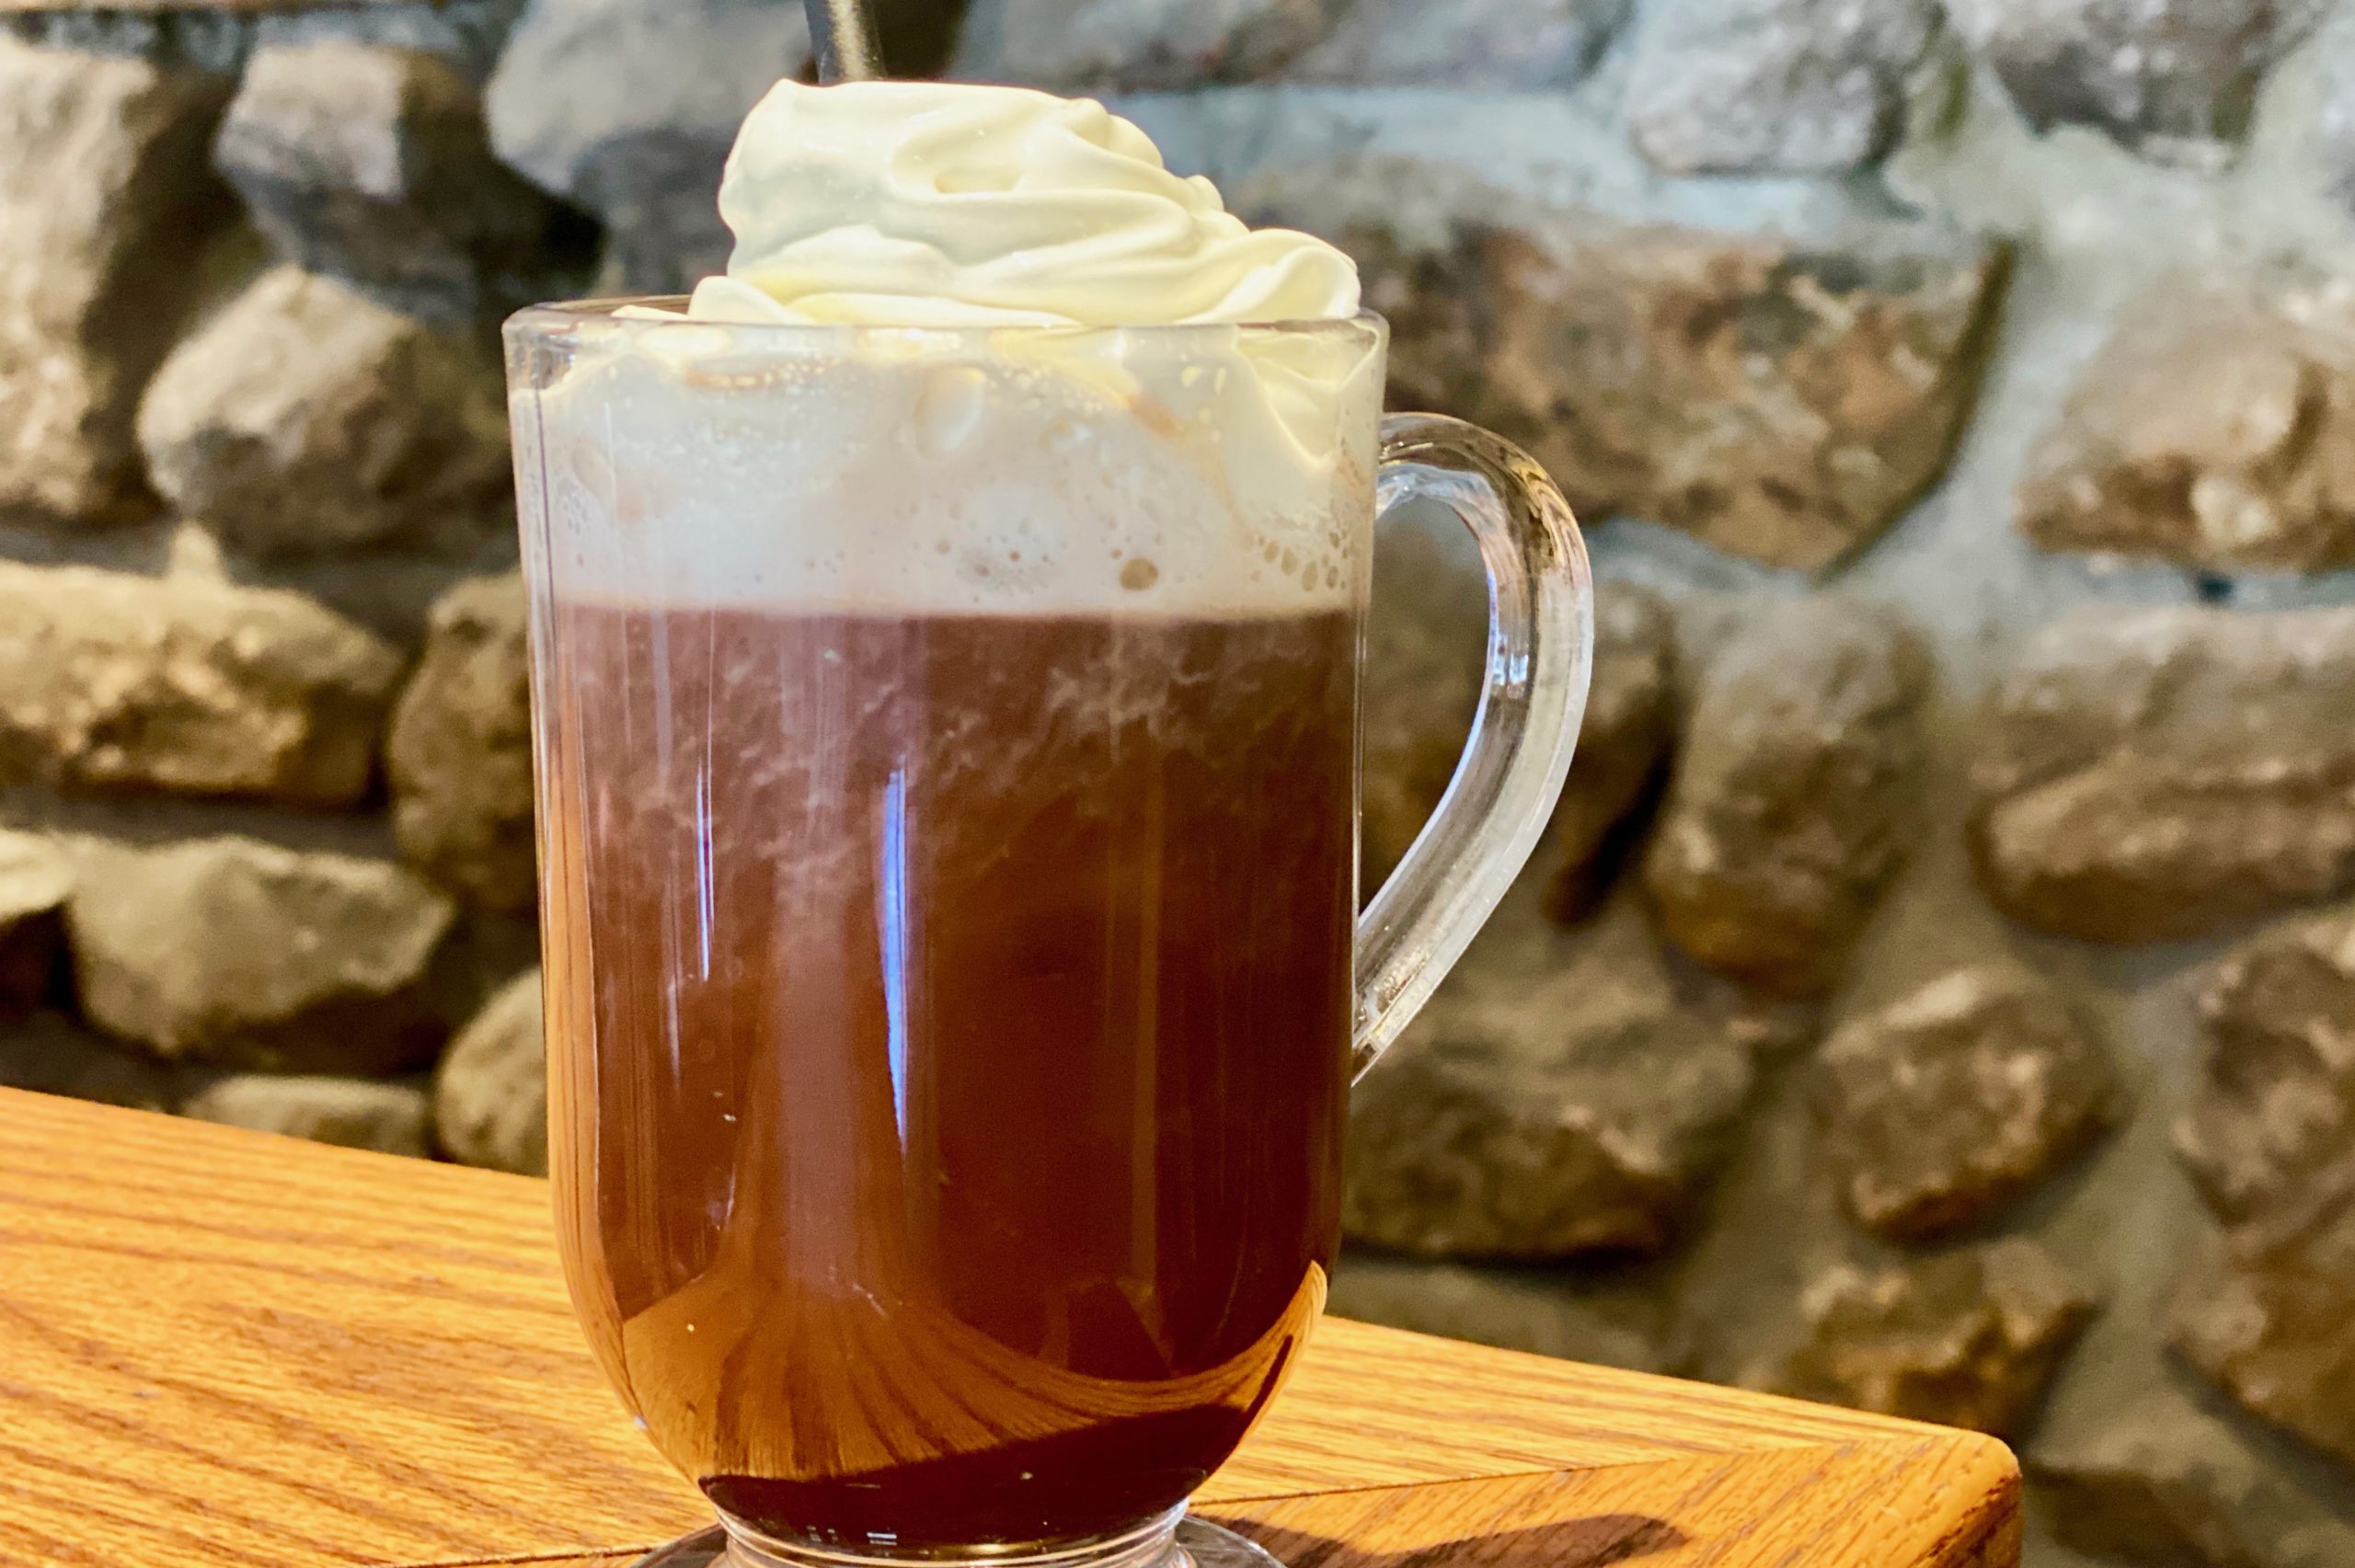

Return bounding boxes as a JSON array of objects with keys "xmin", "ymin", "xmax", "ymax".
[{"xmin": 513, "ymin": 320, "xmax": 1380, "ymax": 617}]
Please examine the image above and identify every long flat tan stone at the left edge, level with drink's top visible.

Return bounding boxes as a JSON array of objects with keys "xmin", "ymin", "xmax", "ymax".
[{"xmin": 0, "ymin": 563, "xmax": 400, "ymax": 806}]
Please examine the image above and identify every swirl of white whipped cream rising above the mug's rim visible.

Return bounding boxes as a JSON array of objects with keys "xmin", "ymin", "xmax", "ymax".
[{"xmin": 688, "ymin": 83, "xmax": 1359, "ymax": 327}]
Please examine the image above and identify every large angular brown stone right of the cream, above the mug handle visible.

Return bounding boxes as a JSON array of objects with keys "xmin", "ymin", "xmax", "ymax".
[{"xmin": 1481, "ymin": 226, "xmax": 1999, "ymax": 570}]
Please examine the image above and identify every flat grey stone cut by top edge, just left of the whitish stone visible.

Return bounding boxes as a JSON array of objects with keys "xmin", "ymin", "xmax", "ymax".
[{"xmin": 1292, "ymin": 0, "xmax": 1630, "ymax": 92}]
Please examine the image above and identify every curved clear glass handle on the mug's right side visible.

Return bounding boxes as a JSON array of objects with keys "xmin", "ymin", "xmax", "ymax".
[{"xmin": 1350, "ymin": 415, "xmax": 1594, "ymax": 1081}]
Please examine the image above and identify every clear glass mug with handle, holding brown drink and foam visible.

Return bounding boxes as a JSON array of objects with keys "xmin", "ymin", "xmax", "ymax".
[{"xmin": 506, "ymin": 302, "xmax": 1592, "ymax": 1565}]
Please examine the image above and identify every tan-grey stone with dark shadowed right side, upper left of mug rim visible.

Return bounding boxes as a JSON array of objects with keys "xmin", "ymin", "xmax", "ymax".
[{"xmin": 214, "ymin": 40, "xmax": 586, "ymax": 325}]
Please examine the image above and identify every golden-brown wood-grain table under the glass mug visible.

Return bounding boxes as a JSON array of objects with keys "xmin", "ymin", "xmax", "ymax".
[{"xmin": 0, "ymin": 1090, "xmax": 2018, "ymax": 1568}]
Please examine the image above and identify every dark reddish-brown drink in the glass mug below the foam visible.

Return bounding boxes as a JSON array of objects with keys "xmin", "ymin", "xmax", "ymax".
[{"xmin": 542, "ymin": 602, "xmax": 1357, "ymax": 1554}]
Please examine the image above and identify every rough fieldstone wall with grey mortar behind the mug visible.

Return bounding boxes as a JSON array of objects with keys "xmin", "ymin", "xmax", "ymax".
[{"xmin": 0, "ymin": 0, "xmax": 2355, "ymax": 1568}]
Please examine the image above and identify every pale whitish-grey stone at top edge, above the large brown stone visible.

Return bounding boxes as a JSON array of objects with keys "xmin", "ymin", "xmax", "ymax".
[{"xmin": 1627, "ymin": 0, "xmax": 1938, "ymax": 174}]
